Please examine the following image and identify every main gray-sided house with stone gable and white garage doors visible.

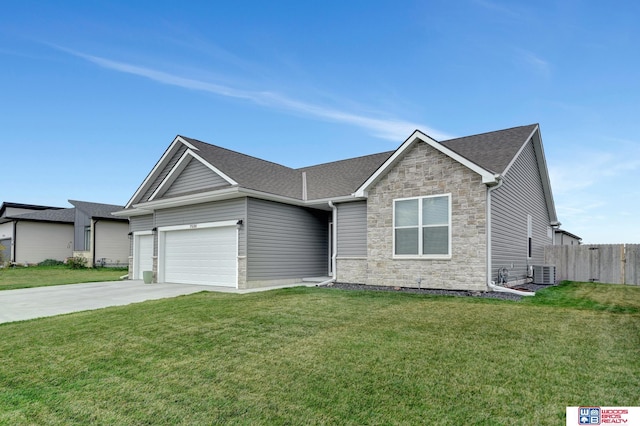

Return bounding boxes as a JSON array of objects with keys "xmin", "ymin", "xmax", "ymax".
[{"xmin": 115, "ymin": 124, "xmax": 559, "ymax": 291}]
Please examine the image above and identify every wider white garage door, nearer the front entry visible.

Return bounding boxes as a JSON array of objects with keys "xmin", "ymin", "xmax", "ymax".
[{"xmin": 162, "ymin": 226, "xmax": 238, "ymax": 287}]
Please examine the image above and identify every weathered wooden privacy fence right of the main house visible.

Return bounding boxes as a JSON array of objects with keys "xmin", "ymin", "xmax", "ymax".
[{"xmin": 544, "ymin": 244, "xmax": 640, "ymax": 285}]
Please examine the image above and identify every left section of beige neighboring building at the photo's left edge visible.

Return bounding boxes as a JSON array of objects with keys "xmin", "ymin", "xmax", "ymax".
[{"xmin": 0, "ymin": 203, "xmax": 74, "ymax": 264}]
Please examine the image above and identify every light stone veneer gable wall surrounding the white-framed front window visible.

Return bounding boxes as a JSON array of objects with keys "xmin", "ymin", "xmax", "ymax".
[{"xmin": 362, "ymin": 142, "xmax": 487, "ymax": 291}]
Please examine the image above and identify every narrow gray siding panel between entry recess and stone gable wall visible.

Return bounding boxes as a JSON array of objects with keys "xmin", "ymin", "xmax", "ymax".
[{"xmin": 337, "ymin": 201, "xmax": 367, "ymax": 257}]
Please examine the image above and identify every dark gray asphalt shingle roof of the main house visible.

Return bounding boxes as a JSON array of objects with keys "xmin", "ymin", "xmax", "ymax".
[{"xmin": 139, "ymin": 124, "xmax": 537, "ymax": 204}]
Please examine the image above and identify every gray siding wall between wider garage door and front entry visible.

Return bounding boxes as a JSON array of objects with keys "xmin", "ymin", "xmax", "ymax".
[{"xmin": 246, "ymin": 198, "xmax": 330, "ymax": 281}]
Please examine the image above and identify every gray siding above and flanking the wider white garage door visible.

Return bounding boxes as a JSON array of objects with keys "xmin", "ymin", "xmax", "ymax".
[{"xmin": 154, "ymin": 198, "xmax": 247, "ymax": 256}]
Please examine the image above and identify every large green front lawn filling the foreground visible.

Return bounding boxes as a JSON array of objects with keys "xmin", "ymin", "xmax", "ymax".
[{"xmin": 0, "ymin": 284, "xmax": 640, "ymax": 425}]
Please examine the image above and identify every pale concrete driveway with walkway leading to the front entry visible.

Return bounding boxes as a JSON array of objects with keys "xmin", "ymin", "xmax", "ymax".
[{"xmin": 0, "ymin": 280, "xmax": 315, "ymax": 323}]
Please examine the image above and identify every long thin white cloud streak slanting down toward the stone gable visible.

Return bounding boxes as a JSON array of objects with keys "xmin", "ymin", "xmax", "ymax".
[{"xmin": 53, "ymin": 46, "xmax": 451, "ymax": 142}]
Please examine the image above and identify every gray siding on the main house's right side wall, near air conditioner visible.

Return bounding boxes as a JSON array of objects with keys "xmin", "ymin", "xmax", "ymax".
[{"xmin": 491, "ymin": 142, "xmax": 552, "ymax": 281}]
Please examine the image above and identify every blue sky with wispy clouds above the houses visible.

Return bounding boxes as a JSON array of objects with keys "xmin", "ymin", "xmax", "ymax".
[{"xmin": 0, "ymin": 0, "xmax": 640, "ymax": 243}]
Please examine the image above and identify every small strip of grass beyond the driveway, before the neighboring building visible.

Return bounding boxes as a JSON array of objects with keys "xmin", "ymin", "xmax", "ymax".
[{"xmin": 0, "ymin": 265, "xmax": 127, "ymax": 290}]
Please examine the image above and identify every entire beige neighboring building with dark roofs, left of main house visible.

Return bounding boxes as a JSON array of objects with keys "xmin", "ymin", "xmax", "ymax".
[{"xmin": 0, "ymin": 200, "xmax": 129, "ymax": 266}]
